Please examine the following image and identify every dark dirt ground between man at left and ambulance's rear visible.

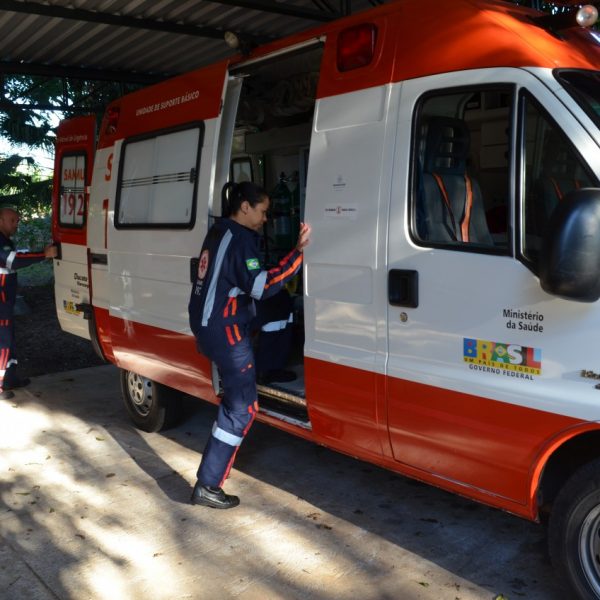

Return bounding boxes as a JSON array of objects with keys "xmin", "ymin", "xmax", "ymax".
[{"xmin": 15, "ymin": 284, "xmax": 104, "ymax": 377}]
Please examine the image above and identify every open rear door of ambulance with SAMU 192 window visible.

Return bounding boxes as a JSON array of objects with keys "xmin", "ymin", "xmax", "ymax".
[{"xmin": 52, "ymin": 115, "xmax": 96, "ymax": 339}]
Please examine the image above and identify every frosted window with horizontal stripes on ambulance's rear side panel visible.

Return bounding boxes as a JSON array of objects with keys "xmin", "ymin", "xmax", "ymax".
[{"xmin": 115, "ymin": 124, "xmax": 203, "ymax": 229}]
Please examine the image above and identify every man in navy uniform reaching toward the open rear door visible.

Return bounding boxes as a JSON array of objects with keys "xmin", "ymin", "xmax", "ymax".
[{"xmin": 0, "ymin": 206, "xmax": 56, "ymax": 398}]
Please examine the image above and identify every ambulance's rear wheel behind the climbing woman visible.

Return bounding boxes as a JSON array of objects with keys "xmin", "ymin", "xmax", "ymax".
[{"xmin": 121, "ymin": 369, "xmax": 181, "ymax": 433}]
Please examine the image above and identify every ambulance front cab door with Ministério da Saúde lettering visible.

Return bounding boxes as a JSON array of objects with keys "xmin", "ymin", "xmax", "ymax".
[{"xmin": 387, "ymin": 69, "xmax": 597, "ymax": 503}]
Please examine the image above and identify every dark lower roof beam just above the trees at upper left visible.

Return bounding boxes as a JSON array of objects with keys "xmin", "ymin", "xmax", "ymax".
[{"xmin": 0, "ymin": 61, "xmax": 167, "ymax": 85}]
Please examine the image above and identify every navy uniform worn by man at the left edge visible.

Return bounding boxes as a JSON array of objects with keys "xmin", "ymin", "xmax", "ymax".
[{"xmin": 0, "ymin": 233, "xmax": 46, "ymax": 392}]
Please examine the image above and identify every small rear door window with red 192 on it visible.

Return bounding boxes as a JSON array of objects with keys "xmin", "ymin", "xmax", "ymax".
[{"xmin": 58, "ymin": 153, "xmax": 86, "ymax": 228}]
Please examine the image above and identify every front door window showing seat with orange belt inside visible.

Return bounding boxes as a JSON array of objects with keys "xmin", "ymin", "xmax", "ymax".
[{"xmin": 412, "ymin": 86, "xmax": 514, "ymax": 254}]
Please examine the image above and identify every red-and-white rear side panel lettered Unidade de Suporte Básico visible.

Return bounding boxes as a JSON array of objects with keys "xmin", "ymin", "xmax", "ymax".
[{"xmin": 90, "ymin": 62, "xmax": 227, "ymax": 386}]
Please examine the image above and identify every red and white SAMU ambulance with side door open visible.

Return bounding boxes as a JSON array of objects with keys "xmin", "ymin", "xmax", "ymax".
[{"xmin": 53, "ymin": 0, "xmax": 600, "ymax": 599}]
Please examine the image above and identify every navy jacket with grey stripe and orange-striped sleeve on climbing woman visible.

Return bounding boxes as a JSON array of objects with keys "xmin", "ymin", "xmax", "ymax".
[{"xmin": 188, "ymin": 218, "xmax": 302, "ymax": 337}]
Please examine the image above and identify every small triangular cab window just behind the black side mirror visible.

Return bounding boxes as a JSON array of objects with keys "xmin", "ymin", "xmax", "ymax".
[{"xmin": 522, "ymin": 94, "xmax": 598, "ymax": 265}]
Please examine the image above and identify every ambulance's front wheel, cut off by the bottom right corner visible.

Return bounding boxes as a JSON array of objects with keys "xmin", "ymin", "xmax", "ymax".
[{"xmin": 548, "ymin": 459, "xmax": 600, "ymax": 600}]
